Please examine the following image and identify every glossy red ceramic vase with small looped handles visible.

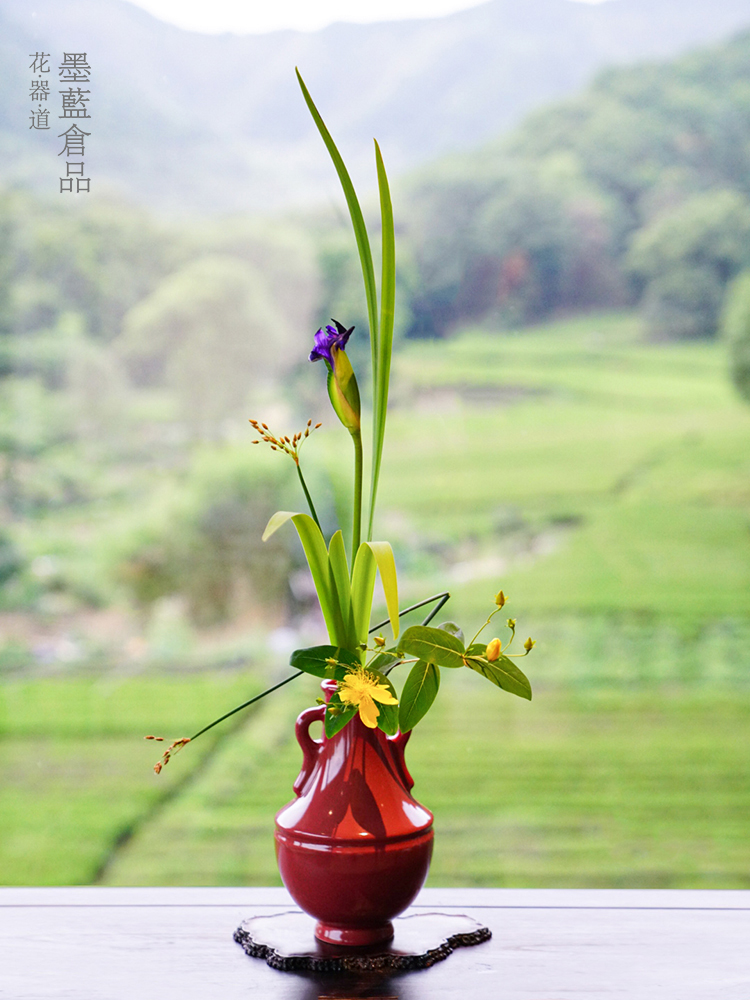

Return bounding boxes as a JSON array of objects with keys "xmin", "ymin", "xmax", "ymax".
[{"xmin": 276, "ymin": 681, "xmax": 433, "ymax": 947}]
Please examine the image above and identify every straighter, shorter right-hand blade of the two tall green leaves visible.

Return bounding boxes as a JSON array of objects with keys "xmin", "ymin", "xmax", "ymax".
[{"xmin": 367, "ymin": 141, "xmax": 396, "ymax": 541}]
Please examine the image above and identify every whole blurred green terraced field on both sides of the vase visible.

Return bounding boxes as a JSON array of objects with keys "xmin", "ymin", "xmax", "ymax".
[{"xmin": 0, "ymin": 315, "xmax": 750, "ymax": 888}]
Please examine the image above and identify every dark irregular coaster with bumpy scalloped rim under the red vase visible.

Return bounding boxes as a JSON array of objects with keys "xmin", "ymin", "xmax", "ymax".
[{"xmin": 234, "ymin": 910, "xmax": 492, "ymax": 972}]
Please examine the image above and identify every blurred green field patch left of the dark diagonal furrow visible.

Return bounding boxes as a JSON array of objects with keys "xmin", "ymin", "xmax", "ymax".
[{"xmin": 0, "ymin": 673, "xmax": 268, "ymax": 885}]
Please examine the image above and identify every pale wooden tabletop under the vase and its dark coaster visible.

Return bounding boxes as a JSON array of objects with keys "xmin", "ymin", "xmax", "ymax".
[{"xmin": 0, "ymin": 887, "xmax": 750, "ymax": 1000}]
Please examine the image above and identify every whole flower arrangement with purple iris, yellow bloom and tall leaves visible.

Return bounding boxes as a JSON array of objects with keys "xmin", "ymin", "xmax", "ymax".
[{"xmin": 146, "ymin": 71, "xmax": 534, "ymax": 773}]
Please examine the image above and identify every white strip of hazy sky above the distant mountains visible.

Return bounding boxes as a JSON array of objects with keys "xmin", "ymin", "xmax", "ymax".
[{"xmin": 131, "ymin": 0, "xmax": 603, "ymax": 34}]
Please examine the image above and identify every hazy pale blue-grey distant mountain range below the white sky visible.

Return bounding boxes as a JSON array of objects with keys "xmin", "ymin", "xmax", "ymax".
[{"xmin": 0, "ymin": 0, "xmax": 750, "ymax": 214}]
